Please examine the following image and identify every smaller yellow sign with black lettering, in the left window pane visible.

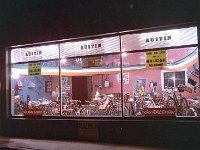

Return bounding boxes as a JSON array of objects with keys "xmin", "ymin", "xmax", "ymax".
[{"xmin": 28, "ymin": 62, "xmax": 41, "ymax": 76}]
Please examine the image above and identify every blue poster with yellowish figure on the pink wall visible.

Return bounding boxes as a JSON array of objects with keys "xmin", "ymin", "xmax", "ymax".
[{"xmin": 134, "ymin": 79, "xmax": 146, "ymax": 95}]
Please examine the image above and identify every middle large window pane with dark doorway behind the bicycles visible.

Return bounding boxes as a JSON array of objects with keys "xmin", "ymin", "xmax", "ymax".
[{"xmin": 61, "ymin": 55, "xmax": 122, "ymax": 117}]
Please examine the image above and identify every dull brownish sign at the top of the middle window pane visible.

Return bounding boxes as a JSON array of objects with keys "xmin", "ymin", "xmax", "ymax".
[{"xmin": 84, "ymin": 56, "xmax": 102, "ymax": 67}]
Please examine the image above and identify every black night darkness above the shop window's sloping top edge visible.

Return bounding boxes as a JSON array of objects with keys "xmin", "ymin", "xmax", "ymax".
[{"xmin": 0, "ymin": 0, "xmax": 200, "ymax": 47}]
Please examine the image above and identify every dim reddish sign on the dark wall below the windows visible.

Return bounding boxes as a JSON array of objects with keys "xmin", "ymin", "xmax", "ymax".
[{"xmin": 78, "ymin": 121, "xmax": 99, "ymax": 140}]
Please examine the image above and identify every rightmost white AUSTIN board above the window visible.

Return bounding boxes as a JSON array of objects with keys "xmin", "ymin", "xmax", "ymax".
[{"xmin": 122, "ymin": 27, "xmax": 198, "ymax": 51}]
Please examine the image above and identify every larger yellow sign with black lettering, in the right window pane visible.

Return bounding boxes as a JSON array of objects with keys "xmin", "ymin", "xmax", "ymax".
[{"xmin": 146, "ymin": 50, "xmax": 167, "ymax": 68}]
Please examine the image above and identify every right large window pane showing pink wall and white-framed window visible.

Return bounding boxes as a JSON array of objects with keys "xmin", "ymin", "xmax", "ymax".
[{"xmin": 122, "ymin": 47, "xmax": 200, "ymax": 117}]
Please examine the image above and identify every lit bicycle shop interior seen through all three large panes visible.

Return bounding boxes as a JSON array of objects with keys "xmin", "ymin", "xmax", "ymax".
[{"xmin": 11, "ymin": 47, "xmax": 200, "ymax": 117}]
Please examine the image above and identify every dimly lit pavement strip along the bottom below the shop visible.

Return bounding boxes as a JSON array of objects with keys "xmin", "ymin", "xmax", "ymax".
[{"xmin": 0, "ymin": 136, "xmax": 170, "ymax": 150}]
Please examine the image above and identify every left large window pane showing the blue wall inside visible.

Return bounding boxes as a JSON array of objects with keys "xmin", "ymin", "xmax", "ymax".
[{"xmin": 11, "ymin": 61, "xmax": 60, "ymax": 116}]
